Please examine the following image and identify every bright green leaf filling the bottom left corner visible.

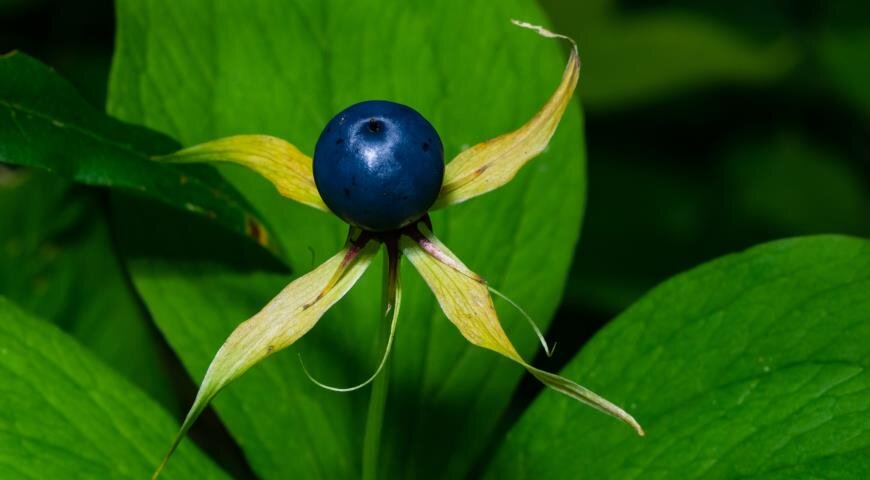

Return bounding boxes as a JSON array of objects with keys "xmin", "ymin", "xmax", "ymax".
[{"xmin": 0, "ymin": 297, "xmax": 227, "ymax": 480}]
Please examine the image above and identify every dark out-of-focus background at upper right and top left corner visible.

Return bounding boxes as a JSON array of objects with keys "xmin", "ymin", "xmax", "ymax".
[{"xmin": 0, "ymin": 0, "xmax": 870, "ymax": 477}]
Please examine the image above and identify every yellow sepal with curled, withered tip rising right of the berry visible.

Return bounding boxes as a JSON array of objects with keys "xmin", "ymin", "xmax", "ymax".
[{"xmin": 435, "ymin": 22, "xmax": 580, "ymax": 208}]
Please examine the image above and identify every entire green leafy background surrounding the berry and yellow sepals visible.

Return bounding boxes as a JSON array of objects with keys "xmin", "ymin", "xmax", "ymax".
[{"xmin": 0, "ymin": 0, "xmax": 870, "ymax": 478}]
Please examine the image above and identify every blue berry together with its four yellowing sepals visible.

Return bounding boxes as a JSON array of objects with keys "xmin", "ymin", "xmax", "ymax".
[{"xmin": 148, "ymin": 22, "xmax": 643, "ymax": 477}]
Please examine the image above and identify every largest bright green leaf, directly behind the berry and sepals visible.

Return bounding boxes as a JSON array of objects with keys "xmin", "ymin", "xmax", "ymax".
[{"xmin": 110, "ymin": 0, "xmax": 584, "ymax": 478}]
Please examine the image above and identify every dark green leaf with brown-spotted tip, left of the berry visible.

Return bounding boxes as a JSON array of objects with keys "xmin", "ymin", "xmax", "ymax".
[{"xmin": 0, "ymin": 52, "xmax": 269, "ymax": 253}]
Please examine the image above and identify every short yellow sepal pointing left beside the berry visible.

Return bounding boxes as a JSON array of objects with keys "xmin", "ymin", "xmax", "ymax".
[{"xmin": 155, "ymin": 135, "xmax": 329, "ymax": 212}]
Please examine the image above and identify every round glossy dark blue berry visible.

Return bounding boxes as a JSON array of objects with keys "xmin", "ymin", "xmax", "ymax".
[{"xmin": 314, "ymin": 100, "xmax": 444, "ymax": 232}]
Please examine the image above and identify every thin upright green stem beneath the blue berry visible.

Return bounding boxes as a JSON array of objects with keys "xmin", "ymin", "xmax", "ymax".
[{"xmin": 362, "ymin": 241, "xmax": 399, "ymax": 480}]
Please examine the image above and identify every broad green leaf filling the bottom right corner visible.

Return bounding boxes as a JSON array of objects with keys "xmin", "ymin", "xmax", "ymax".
[{"xmin": 488, "ymin": 236, "xmax": 870, "ymax": 479}]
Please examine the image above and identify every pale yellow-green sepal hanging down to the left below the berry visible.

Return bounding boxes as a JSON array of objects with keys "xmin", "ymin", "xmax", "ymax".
[{"xmin": 154, "ymin": 241, "xmax": 379, "ymax": 478}]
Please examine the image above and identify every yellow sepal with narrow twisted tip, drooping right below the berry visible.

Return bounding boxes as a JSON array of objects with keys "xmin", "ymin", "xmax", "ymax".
[{"xmin": 401, "ymin": 225, "xmax": 644, "ymax": 435}]
